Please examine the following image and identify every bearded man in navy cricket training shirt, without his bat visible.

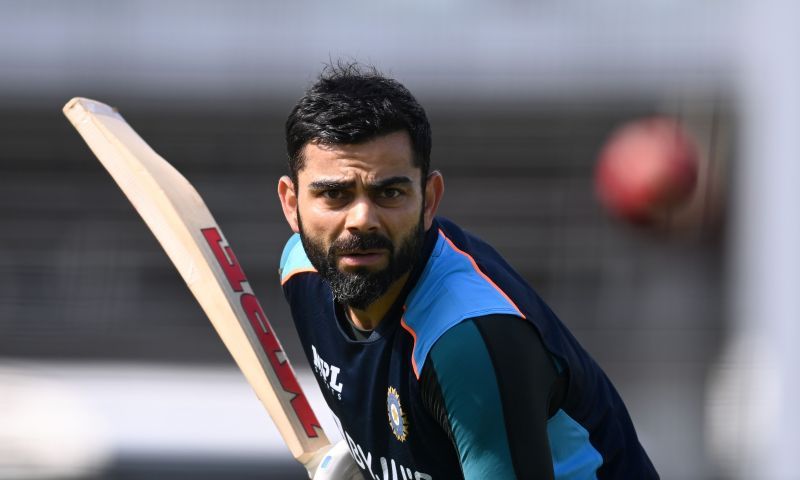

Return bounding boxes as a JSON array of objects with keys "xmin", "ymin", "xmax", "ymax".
[{"xmin": 278, "ymin": 65, "xmax": 658, "ymax": 480}]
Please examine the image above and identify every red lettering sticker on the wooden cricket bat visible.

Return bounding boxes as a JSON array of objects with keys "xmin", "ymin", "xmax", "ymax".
[{"xmin": 201, "ymin": 227, "xmax": 322, "ymax": 437}]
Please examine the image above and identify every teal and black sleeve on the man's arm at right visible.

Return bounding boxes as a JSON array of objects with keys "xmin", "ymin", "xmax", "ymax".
[{"xmin": 420, "ymin": 315, "xmax": 565, "ymax": 480}]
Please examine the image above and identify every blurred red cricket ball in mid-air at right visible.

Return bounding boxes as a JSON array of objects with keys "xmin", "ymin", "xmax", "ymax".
[{"xmin": 595, "ymin": 117, "xmax": 698, "ymax": 224}]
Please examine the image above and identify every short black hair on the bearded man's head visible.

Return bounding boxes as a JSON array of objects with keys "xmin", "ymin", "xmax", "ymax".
[{"xmin": 286, "ymin": 62, "xmax": 431, "ymax": 185}]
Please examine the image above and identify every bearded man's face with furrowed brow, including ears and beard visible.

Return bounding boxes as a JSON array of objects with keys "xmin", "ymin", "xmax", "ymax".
[{"xmin": 279, "ymin": 132, "xmax": 438, "ymax": 309}]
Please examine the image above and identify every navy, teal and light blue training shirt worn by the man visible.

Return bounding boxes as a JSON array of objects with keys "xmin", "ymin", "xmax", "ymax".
[{"xmin": 281, "ymin": 218, "xmax": 658, "ymax": 480}]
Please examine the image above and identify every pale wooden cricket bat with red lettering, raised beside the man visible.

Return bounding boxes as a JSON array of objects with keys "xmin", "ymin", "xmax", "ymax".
[{"xmin": 64, "ymin": 97, "xmax": 330, "ymax": 477}]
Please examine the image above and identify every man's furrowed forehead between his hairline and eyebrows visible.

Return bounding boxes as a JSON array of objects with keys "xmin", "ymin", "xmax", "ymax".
[{"xmin": 298, "ymin": 131, "xmax": 421, "ymax": 183}]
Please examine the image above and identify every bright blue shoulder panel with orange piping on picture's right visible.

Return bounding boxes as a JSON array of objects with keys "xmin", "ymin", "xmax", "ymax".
[{"xmin": 402, "ymin": 229, "xmax": 525, "ymax": 377}]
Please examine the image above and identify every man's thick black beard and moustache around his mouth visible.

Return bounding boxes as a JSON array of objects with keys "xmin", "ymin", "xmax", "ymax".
[{"xmin": 297, "ymin": 213, "xmax": 425, "ymax": 310}]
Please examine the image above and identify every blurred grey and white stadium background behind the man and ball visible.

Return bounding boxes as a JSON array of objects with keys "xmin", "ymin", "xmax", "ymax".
[{"xmin": 0, "ymin": 0, "xmax": 800, "ymax": 480}]
